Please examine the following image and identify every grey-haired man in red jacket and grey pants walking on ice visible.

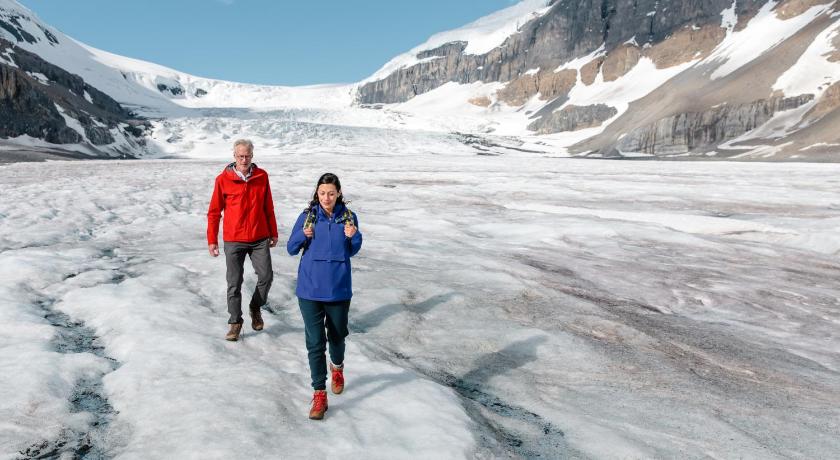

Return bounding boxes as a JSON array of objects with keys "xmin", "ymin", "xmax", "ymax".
[{"xmin": 207, "ymin": 139, "xmax": 277, "ymax": 341}]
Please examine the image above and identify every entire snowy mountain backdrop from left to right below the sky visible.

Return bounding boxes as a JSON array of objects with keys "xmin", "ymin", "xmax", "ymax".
[{"xmin": 0, "ymin": 0, "xmax": 840, "ymax": 161}]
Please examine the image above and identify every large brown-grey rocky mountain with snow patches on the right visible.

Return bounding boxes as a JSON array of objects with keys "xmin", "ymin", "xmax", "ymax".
[{"xmin": 357, "ymin": 0, "xmax": 840, "ymax": 161}]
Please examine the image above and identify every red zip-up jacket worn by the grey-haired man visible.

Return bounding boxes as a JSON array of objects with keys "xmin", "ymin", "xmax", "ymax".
[{"xmin": 207, "ymin": 165, "xmax": 277, "ymax": 244}]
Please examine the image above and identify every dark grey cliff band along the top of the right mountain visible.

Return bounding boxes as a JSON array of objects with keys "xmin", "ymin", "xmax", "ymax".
[{"xmin": 358, "ymin": 0, "xmax": 766, "ymax": 104}]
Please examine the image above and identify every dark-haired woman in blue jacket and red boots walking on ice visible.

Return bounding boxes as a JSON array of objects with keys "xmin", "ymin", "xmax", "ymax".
[{"xmin": 286, "ymin": 173, "xmax": 362, "ymax": 420}]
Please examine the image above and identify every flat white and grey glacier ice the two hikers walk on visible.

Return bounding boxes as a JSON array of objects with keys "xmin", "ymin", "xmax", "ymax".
[{"xmin": 0, "ymin": 155, "xmax": 840, "ymax": 458}]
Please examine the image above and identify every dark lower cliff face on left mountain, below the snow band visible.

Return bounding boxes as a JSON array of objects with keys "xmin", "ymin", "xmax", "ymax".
[{"xmin": 0, "ymin": 39, "xmax": 148, "ymax": 156}]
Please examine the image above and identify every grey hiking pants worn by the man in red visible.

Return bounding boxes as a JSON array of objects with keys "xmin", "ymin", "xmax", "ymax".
[{"xmin": 225, "ymin": 238, "xmax": 274, "ymax": 324}]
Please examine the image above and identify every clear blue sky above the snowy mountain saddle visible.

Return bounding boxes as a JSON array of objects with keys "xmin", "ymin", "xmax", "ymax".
[{"xmin": 18, "ymin": 0, "xmax": 516, "ymax": 85}]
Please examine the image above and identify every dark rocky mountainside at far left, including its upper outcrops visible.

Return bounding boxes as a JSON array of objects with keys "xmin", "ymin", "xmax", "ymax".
[{"xmin": 0, "ymin": 4, "xmax": 150, "ymax": 158}]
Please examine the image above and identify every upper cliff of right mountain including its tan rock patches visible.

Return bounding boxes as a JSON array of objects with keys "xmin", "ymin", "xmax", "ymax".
[{"xmin": 359, "ymin": 0, "xmax": 757, "ymax": 105}]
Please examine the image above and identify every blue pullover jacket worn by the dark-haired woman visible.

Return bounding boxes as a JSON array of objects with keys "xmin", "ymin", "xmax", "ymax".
[{"xmin": 286, "ymin": 204, "xmax": 362, "ymax": 302}]
